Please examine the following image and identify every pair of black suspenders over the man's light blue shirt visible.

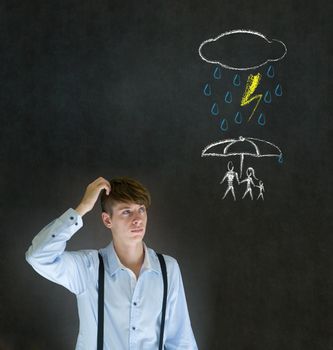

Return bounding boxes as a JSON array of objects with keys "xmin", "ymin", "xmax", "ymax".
[{"xmin": 97, "ymin": 253, "xmax": 168, "ymax": 350}]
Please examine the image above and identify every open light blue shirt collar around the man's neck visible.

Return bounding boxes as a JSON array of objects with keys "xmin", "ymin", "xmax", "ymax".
[{"xmin": 105, "ymin": 242, "xmax": 161, "ymax": 276}]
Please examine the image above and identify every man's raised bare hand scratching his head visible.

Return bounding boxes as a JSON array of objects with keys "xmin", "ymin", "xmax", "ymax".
[{"xmin": 75, "ymin": 177, "xmax": 111, "ymax": 216}]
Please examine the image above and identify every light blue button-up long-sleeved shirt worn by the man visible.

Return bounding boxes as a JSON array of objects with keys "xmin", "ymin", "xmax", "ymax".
[{"xmin": 26, "ymin": 209, "xmax": 197, "ymax": 350}]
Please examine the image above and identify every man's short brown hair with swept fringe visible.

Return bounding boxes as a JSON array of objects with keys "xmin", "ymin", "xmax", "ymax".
[{"xmin": 101, "ymin": 177, "xmax": 151, "ymax": 215}]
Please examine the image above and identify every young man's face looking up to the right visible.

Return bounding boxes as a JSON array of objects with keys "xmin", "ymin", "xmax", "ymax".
[{"xmin": 110, "ymin": 202, "xmax": 147, "ymax": 244}]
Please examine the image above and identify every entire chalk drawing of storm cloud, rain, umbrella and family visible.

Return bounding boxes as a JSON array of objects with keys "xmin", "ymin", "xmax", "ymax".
[{"xmin": 198, "ymin": 29, "xmax": 287, "ymax": 201}]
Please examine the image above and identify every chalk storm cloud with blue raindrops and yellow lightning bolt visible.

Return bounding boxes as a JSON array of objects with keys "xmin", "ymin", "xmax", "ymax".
[{"xmin": 198, "ymin": 29, "xmax": 287, "ymax": 133}]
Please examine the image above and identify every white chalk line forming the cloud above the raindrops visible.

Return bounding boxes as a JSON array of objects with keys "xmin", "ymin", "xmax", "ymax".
[{"xmin": 198, "ymin": 29, "xmax": 287, "ymax": 70}]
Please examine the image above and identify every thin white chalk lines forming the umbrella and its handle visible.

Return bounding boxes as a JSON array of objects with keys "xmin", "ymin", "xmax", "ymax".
[{"xmin": 201, "ymin": 136, "xmax": 282, "ymax": 178}]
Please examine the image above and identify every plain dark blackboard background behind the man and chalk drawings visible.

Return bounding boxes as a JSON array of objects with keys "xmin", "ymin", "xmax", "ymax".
[{"xmin": 0, "ymin": 0, "xmax": 333, "ymax": 350}]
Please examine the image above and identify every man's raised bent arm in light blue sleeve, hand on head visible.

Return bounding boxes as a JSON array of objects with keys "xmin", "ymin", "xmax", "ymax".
[{"xmin": 26, "ymin": 177, "xmax": 111, "ymax": 294}]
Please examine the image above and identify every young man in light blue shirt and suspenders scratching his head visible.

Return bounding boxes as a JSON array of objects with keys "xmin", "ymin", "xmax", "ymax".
[{"xmin": 26, "ymin": 177, "xmax": 197, "ymax": 350}]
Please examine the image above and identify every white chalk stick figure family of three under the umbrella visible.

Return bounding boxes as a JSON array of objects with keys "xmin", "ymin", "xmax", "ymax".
[{"xmin": 220, "ymin": 161, "xmax": 265, "ymax": 201}]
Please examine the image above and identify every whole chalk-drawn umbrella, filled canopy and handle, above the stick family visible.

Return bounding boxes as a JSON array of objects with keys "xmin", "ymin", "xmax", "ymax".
[{"xmin": 201, "ymin": 136, "xmax": 282, "ymax": 177}]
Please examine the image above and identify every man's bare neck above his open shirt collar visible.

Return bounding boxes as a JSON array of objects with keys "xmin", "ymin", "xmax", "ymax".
[{"xmin": 113, "ymin": 241, "xmax": 145, "ymax": 277}]
